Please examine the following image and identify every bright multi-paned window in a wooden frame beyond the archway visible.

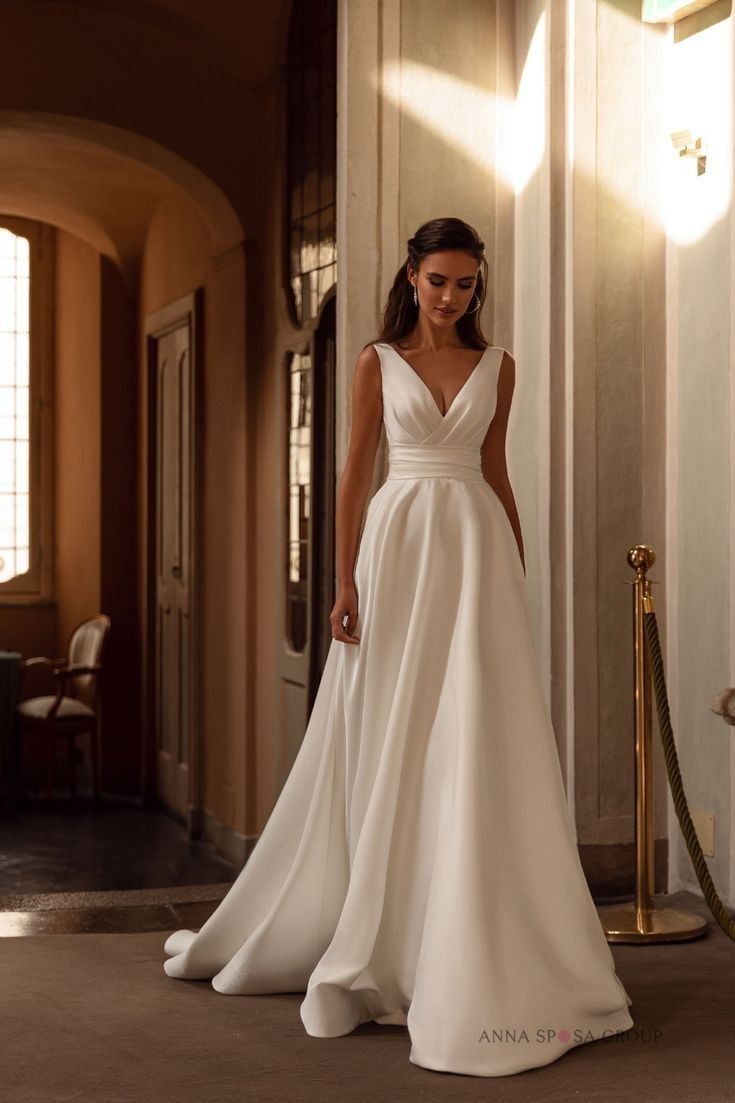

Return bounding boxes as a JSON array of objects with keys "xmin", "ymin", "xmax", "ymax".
[{"xmin": 0, "ymin": 216, "xmax": 53, "ymax": 603}]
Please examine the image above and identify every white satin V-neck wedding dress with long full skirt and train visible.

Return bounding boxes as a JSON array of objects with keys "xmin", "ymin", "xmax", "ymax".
[{"xmin": 164, "ymin": 342, "xmax": 632, "ymax": 1077}]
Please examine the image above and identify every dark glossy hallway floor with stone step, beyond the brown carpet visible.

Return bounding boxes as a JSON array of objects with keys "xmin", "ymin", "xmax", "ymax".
[{"xmin": 0, "ymin": 799, "xmax": 239, "ymax": 938}]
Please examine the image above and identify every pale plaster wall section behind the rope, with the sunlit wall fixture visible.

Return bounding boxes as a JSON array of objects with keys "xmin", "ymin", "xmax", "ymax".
[{"xmin": 659, "ymin": 4, "xmax": 735, "ymax": 906}]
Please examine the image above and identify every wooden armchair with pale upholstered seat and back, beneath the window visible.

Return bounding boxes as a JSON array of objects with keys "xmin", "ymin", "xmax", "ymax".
[{"xmin": 17, "ymin": 613, "xmax": 110, "ymax": 802}]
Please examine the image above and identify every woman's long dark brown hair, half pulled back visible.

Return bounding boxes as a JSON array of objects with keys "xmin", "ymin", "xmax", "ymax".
[{"xmin": 368, "ymin": 218, "xmax": 489, "ymax": 349}]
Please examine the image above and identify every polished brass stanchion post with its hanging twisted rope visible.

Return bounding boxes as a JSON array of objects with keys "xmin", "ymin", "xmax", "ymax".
[{"xmin": 598, "ymin": 544, "xmax": 735, "ymax": 943}]
